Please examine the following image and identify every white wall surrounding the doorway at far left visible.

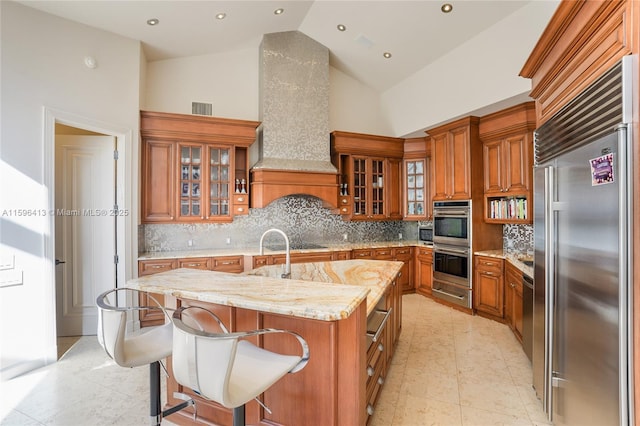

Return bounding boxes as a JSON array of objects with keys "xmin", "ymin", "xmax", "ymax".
[{"xmin": 0, "ymin": 1, "xmax": 140, "ymax": 380}]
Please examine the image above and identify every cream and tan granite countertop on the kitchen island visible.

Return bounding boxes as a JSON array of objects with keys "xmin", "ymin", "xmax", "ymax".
[{"xmin": 127, "ymin": 260, "xmax": 402, "ymax": 321}]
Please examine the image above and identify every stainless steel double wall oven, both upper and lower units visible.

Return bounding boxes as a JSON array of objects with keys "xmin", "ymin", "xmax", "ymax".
[{"xmin": 432, "ymin": 200, "xmax": 472, "ymax": 308}]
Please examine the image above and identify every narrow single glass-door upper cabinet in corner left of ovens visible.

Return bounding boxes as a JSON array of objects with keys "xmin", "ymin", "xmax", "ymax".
[{"xmin": 402, "ymin": 137, "xmax": 433, "ymax": 220}]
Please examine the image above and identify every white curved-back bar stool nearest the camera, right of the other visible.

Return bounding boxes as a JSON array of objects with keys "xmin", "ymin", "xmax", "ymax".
[{"xmin": 172, "ymin": 306, "xmax": 309, "ymax": 426}]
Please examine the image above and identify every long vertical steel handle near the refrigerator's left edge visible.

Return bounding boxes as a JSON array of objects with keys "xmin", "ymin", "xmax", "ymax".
[{"xmin": 543, "ymin": 166, "xmax": 556, "ymax": 421}]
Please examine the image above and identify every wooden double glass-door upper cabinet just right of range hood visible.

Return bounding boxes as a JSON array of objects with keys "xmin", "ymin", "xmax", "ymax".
[{"xmin": 331, "ymin": 131, "xmax": 404, "ymax": 220}]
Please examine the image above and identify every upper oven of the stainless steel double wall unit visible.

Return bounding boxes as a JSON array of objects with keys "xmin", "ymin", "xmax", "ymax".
[{"xmin": 433, "ymin": 200, "xmax": 471, "ymax": 247}]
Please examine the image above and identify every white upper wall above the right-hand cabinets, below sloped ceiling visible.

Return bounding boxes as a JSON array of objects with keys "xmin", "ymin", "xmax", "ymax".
[{"xmin": 381, "ymin": 0, "xmax": 559, "ymax": 136}]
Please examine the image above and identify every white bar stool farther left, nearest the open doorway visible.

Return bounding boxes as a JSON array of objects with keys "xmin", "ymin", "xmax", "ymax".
[{"xmin": 96, "ymin": 287, "xmax": 195, "ymax": 425}]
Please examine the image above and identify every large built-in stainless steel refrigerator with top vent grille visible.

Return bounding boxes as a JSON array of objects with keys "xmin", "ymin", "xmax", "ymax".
[{"xmin": 532, "ymin": 56, "xmax": 637, "ymax": 426}]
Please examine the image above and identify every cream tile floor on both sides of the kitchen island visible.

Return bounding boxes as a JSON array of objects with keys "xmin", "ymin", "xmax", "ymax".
[{"xmin": 0, "ymin": 295, "xmax": 547, "ymax": 426}]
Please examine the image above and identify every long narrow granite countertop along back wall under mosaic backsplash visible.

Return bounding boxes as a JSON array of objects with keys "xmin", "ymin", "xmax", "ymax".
[{"xmin": 138, "ymin": 240, "xmax": 424, "ymax": 260}]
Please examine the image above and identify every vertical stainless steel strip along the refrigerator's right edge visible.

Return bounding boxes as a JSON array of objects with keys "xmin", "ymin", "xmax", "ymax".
[{"xmin": 616, "ymin": 124, "xmax": 633, "ymax": 424}]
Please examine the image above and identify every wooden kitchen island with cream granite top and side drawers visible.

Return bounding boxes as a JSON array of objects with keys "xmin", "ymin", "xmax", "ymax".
[{"xmin": 128, "ymin": 260, "xmax": 402, "ymax": 425}]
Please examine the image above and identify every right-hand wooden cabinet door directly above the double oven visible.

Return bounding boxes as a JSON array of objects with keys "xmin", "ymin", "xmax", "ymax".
[{"xmin": 448, "ymin": 125, "xmax": 471, "ymax": 200}]
